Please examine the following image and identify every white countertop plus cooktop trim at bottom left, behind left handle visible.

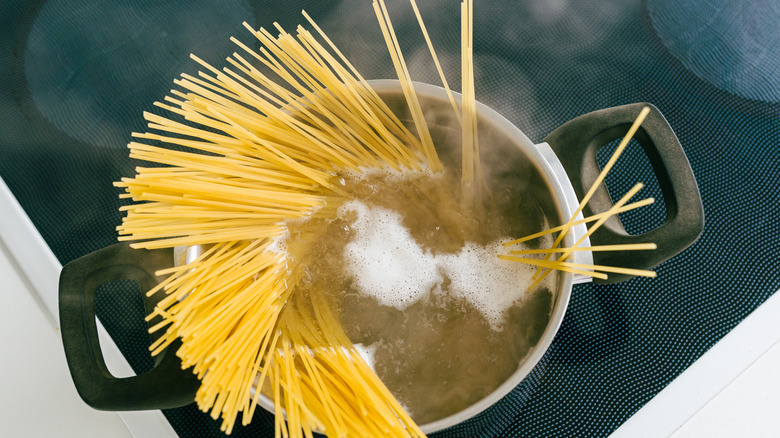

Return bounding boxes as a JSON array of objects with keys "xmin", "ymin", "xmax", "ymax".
[{"xmin": 0, "ymin": 179, "xmax": 176, "ymax": 438}]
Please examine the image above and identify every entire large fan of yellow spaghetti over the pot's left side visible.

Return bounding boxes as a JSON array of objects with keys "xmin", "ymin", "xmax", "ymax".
[{"xmin": 115, "ymin": 13, "xmax": 448, "ymax": 436}]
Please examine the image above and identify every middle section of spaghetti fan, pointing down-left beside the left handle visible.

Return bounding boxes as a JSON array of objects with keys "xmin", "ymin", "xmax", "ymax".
[{"xmin": 147, "ymin": 240, "xmax": 299, "ymax": 431}]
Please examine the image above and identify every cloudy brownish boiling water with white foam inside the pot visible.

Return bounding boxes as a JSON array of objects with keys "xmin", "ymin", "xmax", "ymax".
[{"xmin": 286, "ymin": 167, "xmax": 555, "ymax": 424}]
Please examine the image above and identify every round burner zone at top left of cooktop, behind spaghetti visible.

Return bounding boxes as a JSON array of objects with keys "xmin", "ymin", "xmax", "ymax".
[{"xmin": 25, "ymin": 0, "xmax": 254, "ymax": 148}]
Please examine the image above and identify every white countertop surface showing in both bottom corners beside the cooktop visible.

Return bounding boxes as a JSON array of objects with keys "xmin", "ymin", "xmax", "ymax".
[{"xmin": 0, "ymin": 175, "xmax": 780, "ymax": 438}]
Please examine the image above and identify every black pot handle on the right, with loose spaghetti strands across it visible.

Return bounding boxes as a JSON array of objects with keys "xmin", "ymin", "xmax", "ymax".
[{"xmin": 544, "ymin": 103, "xmax": 704, "ymax": 283}]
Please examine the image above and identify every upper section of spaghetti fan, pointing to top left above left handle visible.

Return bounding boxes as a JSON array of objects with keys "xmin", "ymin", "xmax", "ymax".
[{"xmin": 116, "ymin": 18, "xmax": 442, "ymax": 248}]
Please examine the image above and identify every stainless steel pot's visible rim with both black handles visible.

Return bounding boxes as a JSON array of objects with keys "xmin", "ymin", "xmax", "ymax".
[{"xmin": 60, "ymin": 80, "xmax": 704, "ymax": 433}]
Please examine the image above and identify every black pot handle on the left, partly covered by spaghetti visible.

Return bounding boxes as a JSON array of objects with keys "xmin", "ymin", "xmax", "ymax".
[{"xmin": 59, "ymin": 243, "xmax": 200, "ymax": 411}]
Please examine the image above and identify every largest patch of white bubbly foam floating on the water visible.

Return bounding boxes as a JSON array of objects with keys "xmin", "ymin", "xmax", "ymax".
[{"xmin": 339, "ymin": 201, "xmax": 548, "ymax": 329}]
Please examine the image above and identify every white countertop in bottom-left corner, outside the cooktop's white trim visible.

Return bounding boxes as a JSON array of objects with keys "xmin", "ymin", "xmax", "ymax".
[{"xmin": 0, "ymin": 233, "xmax": 132, "ymax": 438}]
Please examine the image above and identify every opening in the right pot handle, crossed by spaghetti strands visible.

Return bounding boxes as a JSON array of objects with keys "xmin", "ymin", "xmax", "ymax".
[{"xmin": 596, "ymin": 138, "xmax": 667, "ymax": 235}]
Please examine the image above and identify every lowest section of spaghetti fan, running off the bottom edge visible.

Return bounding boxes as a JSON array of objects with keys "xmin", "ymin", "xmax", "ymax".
[{"xmin": 260, "ymin": 293, "xmax": 424, "ymax": 437}]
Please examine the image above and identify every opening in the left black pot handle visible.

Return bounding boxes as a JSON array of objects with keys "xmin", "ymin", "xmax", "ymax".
[{"xmin": 95, "ymin": 279, "xmax": 154, "ymax": 377}]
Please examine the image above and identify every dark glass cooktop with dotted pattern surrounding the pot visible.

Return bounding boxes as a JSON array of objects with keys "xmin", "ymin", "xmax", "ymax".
[{"xmin": 0, "ymin": 0, "xmax": 780, "ymax": 438}]
